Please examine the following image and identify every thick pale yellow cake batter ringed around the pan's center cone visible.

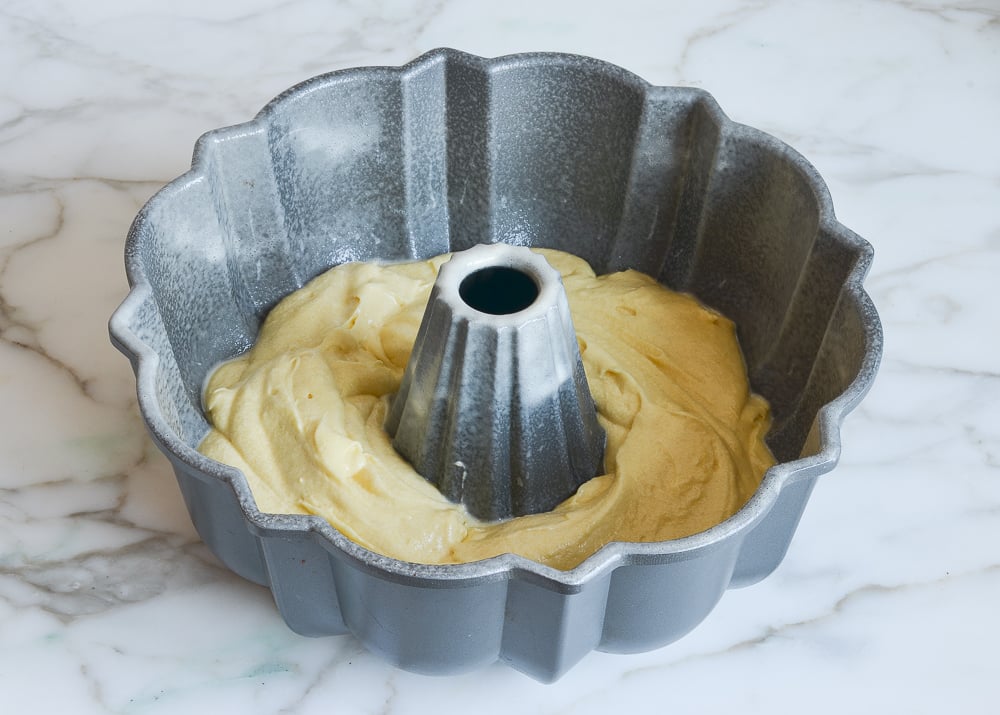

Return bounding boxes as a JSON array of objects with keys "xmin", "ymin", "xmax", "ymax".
[{"xmin": 200, "ymin": 250, "xmax": 774, "ymax": 569}]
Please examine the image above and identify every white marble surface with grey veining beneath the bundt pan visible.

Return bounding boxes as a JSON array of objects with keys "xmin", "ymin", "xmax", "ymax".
[{"xmin": 0, "ymin": 0, "xmax": 1000, "ymax": 713}]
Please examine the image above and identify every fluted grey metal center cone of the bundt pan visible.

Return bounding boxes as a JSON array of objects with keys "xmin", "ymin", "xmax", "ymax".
[{"xmin": 385, "ymin": 243, "xmax": 605, "ymax": 521}]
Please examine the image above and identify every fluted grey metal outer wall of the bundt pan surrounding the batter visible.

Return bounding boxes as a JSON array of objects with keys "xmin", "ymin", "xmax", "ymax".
[{"xmin": 110, "ymin": 50, "xmax": 881, "ymax": 681}]
